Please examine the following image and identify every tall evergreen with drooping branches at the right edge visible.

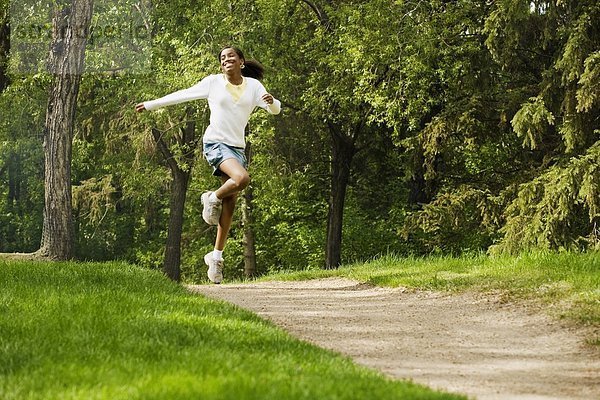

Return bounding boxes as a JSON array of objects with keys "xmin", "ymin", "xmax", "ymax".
[{"xmin": 485, "ymin": 1, "xmax": 600, "ymax": 252}]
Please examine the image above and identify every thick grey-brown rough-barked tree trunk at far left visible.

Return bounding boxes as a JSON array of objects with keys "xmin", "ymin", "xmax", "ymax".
[{"xmin": 39, "ymin": 0, "xmax": 93, "ymax": 260}]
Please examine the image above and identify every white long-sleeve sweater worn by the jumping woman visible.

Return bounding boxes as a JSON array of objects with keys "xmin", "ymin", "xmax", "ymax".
[{"xmin": 144, "ymin": 74, "xmax": 281, "ymax": 148}]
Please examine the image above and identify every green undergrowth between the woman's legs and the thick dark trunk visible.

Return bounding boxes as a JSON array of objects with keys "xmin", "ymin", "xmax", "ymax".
[{"xmin": 250, "ymin": 132, "xmax": 327, "ymax": 272}]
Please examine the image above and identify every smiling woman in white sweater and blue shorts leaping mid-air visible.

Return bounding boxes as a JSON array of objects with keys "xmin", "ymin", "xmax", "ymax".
[{"xmin": 135, "ymin": 47, "xmax": 281, "ymax": 283}]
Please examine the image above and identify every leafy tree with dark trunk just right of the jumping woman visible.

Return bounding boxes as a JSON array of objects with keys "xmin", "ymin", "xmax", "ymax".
[{"xmin": 254, "ymin": 0, "xmax": 398, "ymax": 268}]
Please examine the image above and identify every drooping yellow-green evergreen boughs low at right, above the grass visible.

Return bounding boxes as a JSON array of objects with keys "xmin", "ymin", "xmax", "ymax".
[{"xmin": 494, "ymin": 142, "xmax": 600, "ymax": 252}]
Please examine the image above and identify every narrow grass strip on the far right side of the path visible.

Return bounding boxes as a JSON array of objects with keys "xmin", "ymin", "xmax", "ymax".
[{"xmin": 264, "ymin": 252, "xmax": 600, "ymax": 330}]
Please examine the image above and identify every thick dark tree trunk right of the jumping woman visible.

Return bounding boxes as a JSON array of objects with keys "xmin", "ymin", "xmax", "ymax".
[{"xmin": 325, "ymin": 125, "xmax": 356, "ymax": 269}]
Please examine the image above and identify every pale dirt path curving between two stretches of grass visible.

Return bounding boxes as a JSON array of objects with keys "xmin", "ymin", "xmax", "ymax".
[{"xmin": 191, "ymin": 279, "xmax": 600, "ymax": 400}]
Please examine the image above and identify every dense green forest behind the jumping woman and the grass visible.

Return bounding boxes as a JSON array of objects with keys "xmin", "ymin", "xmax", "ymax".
[{"xmin": 0, "ymin": 0, "xmax": 600, "ymax": 280}]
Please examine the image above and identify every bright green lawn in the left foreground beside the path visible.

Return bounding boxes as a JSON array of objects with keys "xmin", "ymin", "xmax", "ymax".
[{"xmin": 0, "ymin": 261, "xmax": 462, "ymax": 400}]
